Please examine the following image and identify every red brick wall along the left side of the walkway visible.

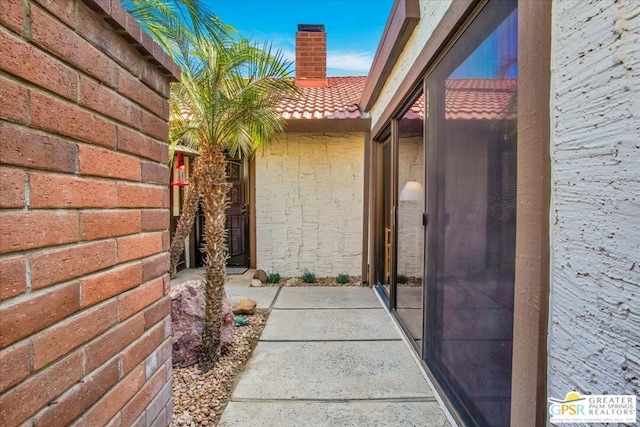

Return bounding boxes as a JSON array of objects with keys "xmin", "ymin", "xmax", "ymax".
[{"xmin": 0, "ymin": 0, "xmax": 179, "ymax": 426}]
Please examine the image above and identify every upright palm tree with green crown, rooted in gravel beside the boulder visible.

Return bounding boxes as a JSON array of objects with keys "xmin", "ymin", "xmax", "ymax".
[{"xmin": 170, "ymin": 39, "xmax": 295, "ymax": 371}]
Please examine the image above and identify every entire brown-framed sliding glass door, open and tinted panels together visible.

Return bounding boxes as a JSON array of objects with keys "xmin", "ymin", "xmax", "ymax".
[{"xmin": 373, "ymin": 0, "xmax": 518, "ymax": 426}]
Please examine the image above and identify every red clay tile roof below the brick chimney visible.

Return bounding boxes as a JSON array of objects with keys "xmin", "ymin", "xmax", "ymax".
[{"xmin": 278, "ymin": 76, "xmax": 366, "ymax": 119}]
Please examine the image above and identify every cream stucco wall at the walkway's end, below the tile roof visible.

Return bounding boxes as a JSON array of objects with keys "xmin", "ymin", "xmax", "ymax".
[{"xmin": 256, "ymin": 133, "xmax": 364, "ymax": 277}]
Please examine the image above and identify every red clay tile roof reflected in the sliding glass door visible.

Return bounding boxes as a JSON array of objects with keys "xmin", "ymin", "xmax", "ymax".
[{"xmin": 411, "ymin": 79, "xmax": 518, "ymax": 120}]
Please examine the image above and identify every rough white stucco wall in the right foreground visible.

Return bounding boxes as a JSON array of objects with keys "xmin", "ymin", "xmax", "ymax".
[{"xmin": 548, "ymin": 0, "xmax": 640, "ymax": 402}]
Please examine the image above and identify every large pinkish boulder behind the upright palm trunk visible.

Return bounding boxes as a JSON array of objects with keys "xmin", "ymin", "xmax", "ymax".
[{"xmin": 169, "ymin": 280, "xmax": 235, "ymax": 368}]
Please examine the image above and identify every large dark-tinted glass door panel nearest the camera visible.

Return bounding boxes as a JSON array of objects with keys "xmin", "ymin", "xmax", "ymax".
[{"xmin": 423, "ymin": 1, "xmax": 517, "ymax": 426}]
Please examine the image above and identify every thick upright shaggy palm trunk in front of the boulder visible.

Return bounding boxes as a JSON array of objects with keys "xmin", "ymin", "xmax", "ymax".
[{"xmin": 200, "ymin": 146, "xmax": 231, "ymax": 372}]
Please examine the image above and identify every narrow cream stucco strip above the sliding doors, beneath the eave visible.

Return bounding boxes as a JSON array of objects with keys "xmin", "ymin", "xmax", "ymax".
[{"xmin": 370, "ymin": 0, "xmax": 453, "ymax": 129}]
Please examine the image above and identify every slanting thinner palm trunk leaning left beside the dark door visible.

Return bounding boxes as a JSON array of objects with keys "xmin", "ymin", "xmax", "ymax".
[{"xmin": 169, "ymin": 162, "xmax": 202, "ymax": 277}]
